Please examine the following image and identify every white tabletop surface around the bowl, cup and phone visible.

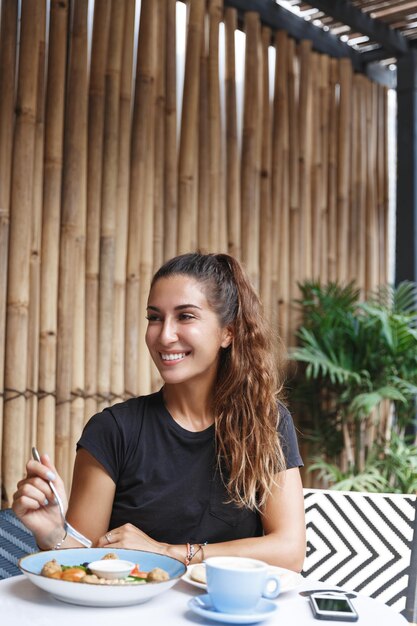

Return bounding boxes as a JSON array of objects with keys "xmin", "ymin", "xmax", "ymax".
[{"xmin": 0, "ymin": 576, "xmax": 408, "ymax": 626}]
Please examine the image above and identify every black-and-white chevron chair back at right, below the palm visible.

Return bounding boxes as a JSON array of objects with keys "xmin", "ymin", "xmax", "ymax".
[{"xmin": 302, "ymin": 489, "xmax": 417, "ymax": 614}]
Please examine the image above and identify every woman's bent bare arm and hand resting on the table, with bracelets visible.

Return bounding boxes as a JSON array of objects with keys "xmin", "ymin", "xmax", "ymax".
[{"xmin": 96, "ymin": 468, "xmax": 306, "ymax": 572}]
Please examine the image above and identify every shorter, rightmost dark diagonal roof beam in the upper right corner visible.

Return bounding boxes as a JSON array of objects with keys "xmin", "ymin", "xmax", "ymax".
[{"xmin": 309, "ymin": 0, "xmax": 409, "ymax": 56}]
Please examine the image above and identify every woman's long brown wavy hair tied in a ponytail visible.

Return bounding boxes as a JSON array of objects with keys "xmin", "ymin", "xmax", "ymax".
[{"xmin": 152, "ymin": 252, "xmax": 285, "ymax": 510}]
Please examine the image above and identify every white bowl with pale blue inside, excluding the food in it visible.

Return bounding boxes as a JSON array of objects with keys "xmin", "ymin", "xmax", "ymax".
[{"xmin": 19, "ymin": 548, "xmax": 186, "ymax": 607}]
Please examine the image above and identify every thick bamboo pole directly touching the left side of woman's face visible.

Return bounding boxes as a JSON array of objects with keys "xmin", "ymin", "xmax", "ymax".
[{"xmin": 125, "ymin": 0, "xmax": 156, "ymax": 395}]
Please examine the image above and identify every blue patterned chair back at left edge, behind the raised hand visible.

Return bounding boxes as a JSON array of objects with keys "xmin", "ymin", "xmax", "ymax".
[{"xmin": 0, "ymin": 509, "xmax": 38, "ymax": 579}]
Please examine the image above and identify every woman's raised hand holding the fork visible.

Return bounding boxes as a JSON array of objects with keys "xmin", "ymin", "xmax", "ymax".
[{"xmin": 12, "ymin": 454, "xmax": 67, "ymax": 548}]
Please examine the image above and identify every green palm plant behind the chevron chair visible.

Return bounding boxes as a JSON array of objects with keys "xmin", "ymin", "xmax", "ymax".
[{"xmin": 290, "ymin": 281, "xmax": 417, "ymax": 490}]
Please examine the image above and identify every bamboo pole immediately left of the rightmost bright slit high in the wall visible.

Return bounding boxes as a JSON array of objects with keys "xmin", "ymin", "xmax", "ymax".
[{"xmin": 259, "ymin": 26, "xmax": 277, "ymax": 321}]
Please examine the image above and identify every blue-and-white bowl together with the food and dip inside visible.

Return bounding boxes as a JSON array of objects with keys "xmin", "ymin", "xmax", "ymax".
[{"xmin": 19, "ymin": 548, "xmax": 186, "ymax": 607}]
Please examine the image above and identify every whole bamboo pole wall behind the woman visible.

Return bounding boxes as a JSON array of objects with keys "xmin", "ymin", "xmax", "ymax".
[{"xmin": 0, "ymin": 0, "xmax": 388, "ymax": 502}]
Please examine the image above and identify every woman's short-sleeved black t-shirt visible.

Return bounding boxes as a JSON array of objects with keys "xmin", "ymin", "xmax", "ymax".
[{"xmin": 77, "ymin": 391, "xmax": 302, "ymax": 543}]
